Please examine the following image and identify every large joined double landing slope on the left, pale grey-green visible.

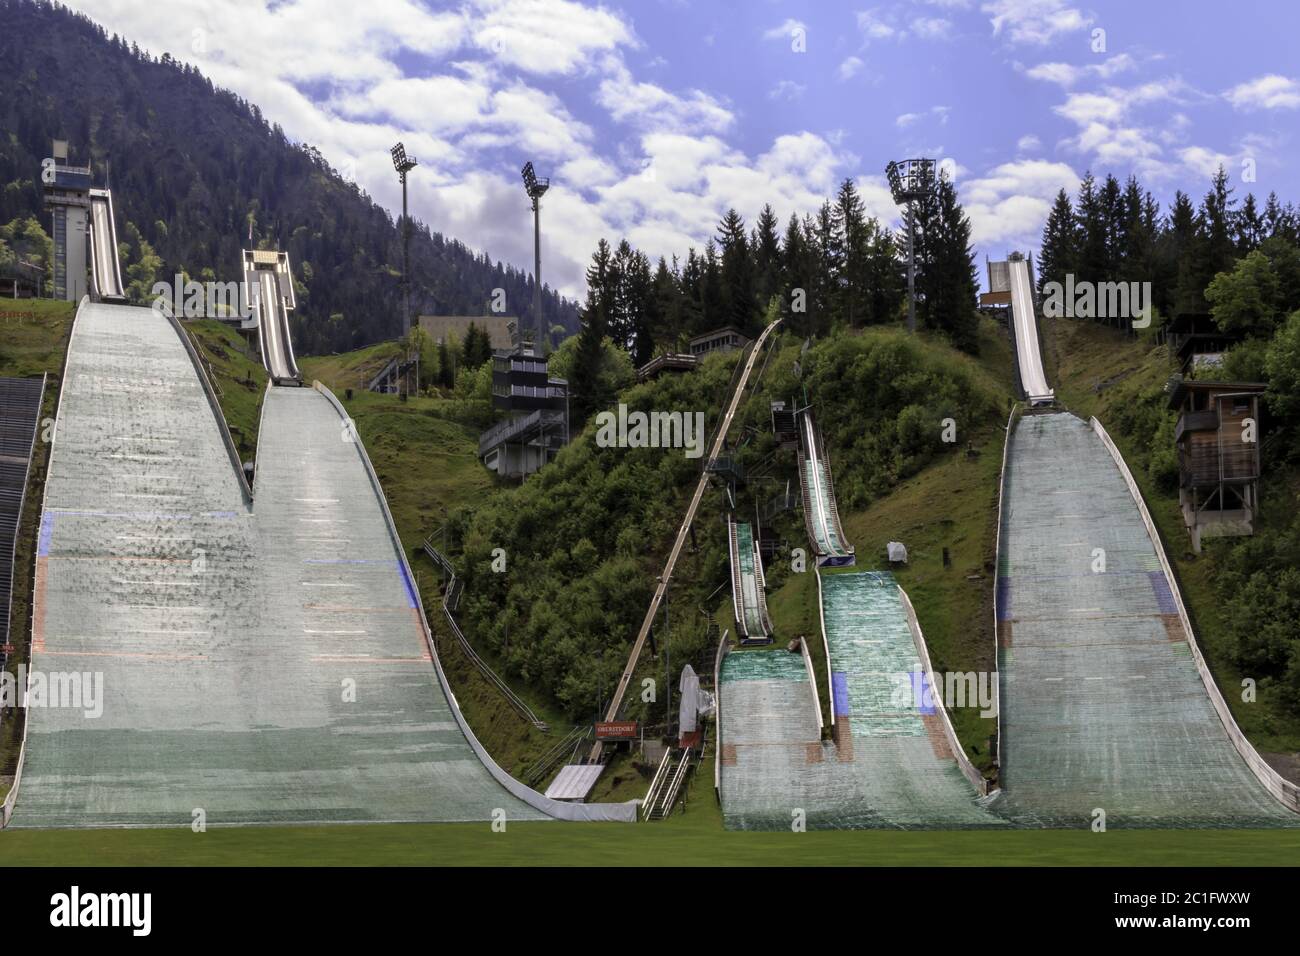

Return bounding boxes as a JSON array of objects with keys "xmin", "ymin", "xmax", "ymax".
[{"xmin": 12, "ymin": 304, "xmax": 631, "ymax": 827}]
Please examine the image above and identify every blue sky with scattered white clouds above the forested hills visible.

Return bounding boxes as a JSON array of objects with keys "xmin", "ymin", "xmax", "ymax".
[{"xmin": 70, "ymin": 0, "xmax": 1300, "ymax": 297}]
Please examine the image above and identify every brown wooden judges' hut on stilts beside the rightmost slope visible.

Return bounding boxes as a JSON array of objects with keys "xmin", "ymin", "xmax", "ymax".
[{"xmin": 1167, "ymin": 376, "xmax": 1264, "ymax": 554}]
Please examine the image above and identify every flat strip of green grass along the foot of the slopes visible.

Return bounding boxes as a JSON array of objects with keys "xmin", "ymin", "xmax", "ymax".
[{"xmin": 0, "ymin": 816, "xmax": 1300, "ymax": 866}]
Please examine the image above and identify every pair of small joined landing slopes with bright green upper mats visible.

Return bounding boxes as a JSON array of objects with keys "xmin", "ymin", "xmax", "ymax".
[{"xmin": 719, "ymin": 572, "xmax": 1006, "ymax": 830}]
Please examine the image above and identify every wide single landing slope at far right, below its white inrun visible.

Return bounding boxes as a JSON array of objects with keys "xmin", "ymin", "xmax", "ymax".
[{"xmin": 996, "ymin": 412, "xmax": 1300, "ymax": 827}]
